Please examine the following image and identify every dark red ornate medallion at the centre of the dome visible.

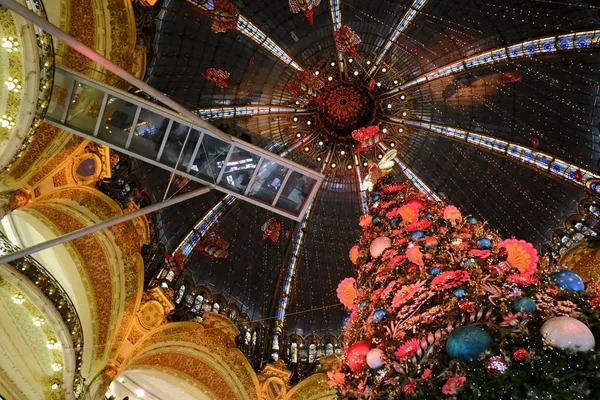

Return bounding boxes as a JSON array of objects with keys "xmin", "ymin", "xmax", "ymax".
[{"xmin": 320, "ymin": 84, "xmax": 375, "ymax": 137}]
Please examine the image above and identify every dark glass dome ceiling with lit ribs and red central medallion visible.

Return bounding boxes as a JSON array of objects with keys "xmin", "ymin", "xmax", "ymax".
[{"xmin": 145, "ymin": 0, "xmax": 600, "ymax": 344}]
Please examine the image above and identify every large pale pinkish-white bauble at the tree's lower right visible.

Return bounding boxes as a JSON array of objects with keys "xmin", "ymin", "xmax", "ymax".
[{"xmin": 540, "ymin": 317, "xmax": 595, "ymax": 351}]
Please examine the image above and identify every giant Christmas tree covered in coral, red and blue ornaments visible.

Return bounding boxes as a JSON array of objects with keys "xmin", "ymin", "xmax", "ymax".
[{"xmin": 329, "ymin": 173, "xmax": 600, "ymax": 400}]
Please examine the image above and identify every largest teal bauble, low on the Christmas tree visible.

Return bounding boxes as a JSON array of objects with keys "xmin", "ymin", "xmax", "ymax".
[{"xmin": 446, "ymin": 326, "xmax": 493, "ymax": 362}]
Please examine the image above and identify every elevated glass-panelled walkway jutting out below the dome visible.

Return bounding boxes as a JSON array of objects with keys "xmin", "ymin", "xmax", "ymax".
[{"xmin": 45, "ymin": 68, "xmax": 323, "ymax": 221}]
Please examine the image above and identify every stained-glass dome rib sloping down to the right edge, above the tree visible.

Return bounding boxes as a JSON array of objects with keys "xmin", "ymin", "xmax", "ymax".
[{"xmin": 380, "ymin": 117, "xmax": 600, "ymax": 193}]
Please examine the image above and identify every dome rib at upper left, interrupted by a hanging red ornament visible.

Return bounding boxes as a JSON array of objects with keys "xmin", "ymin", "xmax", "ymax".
[{"xmin": 187, "ymin": 0, "xmax": 305, "ymax": 71}]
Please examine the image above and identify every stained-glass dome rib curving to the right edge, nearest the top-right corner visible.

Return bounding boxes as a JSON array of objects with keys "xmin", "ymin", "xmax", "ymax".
[{"xmin": 381, "ymin": 30, "xmax": 600, "ymax": 97}]
